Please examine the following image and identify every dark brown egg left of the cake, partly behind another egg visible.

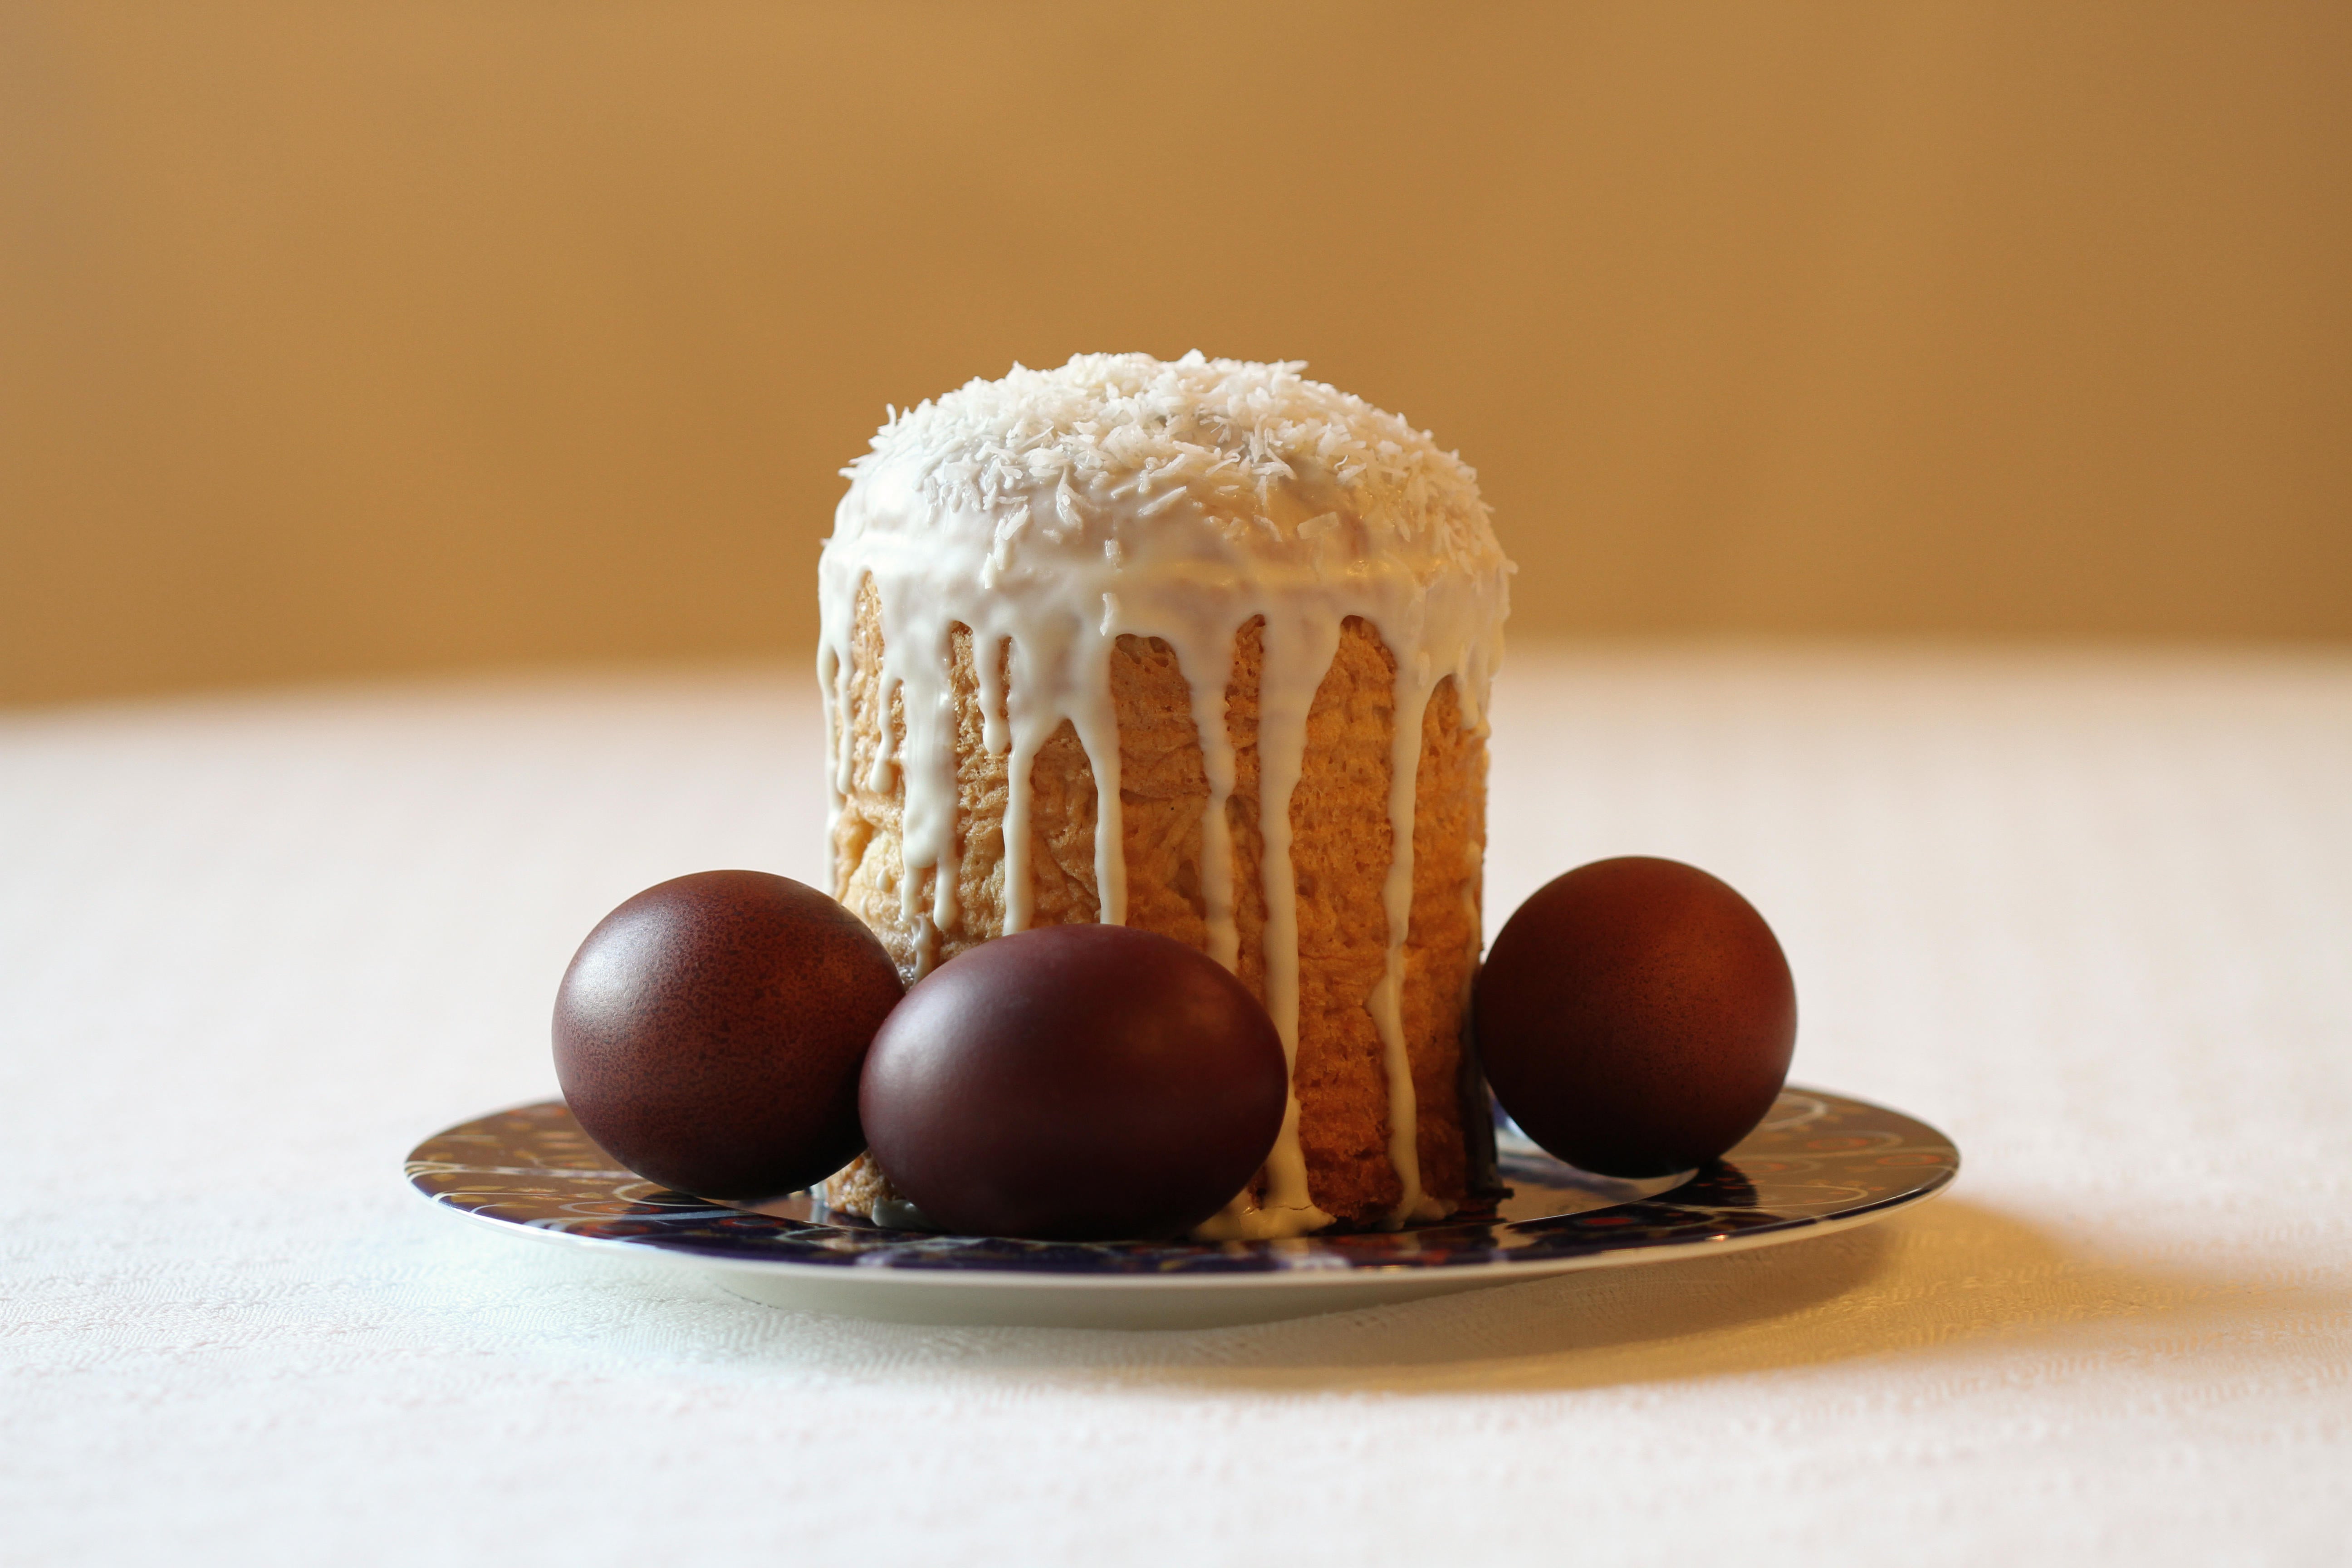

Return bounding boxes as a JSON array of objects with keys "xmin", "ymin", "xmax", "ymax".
[{"xmin": 555, "ymin": 872, "xmax": 901, "ymax": 1201}]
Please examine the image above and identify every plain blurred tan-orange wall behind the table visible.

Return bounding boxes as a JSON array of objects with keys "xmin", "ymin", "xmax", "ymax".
[{"xmin": 0, "ymin": 0, "xmax": 2352, "ymax": 701}]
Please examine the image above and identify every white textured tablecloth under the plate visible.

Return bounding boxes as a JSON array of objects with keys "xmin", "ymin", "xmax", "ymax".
[{"xmin": 0, "ymin": 647, "xmax": 2352, "ymax": 1568}]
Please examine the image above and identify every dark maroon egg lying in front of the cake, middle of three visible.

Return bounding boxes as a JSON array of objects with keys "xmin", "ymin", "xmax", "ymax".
[{"xmin": 858, "ymin": 926, "xmax": 1289, "ymax": 1241}]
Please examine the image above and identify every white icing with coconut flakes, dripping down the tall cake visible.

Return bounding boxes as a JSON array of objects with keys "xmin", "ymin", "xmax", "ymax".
[{"xmin": 816, "ymin": 355, "xmax": 1510, "ymax": 1239}]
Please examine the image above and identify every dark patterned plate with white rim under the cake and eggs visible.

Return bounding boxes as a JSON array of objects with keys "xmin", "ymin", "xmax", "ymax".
[{"xmin": 407, "ymin": 1088, "xmax": 1959, "ymax": 1328}]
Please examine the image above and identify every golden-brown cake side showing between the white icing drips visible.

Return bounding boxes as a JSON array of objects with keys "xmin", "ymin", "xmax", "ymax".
[{"xmin": 833, "ymin": 581, "xmax": 1486, "ymax": 1225}]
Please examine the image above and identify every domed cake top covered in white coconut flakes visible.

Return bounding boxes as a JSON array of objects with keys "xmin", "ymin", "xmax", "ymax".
[{"xmin": 842, "ymin": 353, "xmax": 1503, "ymax": 583}]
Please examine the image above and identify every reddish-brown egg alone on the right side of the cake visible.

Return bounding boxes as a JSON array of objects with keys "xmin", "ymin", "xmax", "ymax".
[{"xmin": 1475, "ymin": 856, "xmax": 1797, "ymax": 1176}]
